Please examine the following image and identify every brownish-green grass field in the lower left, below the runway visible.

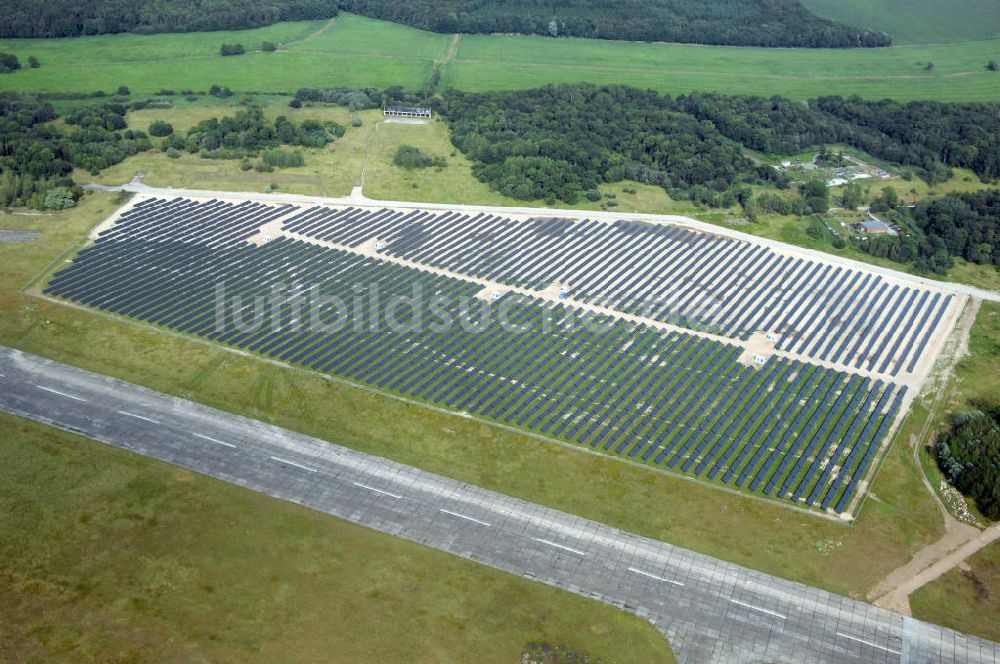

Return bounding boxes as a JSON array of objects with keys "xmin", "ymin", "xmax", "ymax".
[{"xmin": 0, "ymin": 414, "xmax": 674, "ymax": 662}]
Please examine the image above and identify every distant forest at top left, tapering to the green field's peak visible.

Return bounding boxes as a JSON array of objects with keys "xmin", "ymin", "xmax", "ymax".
[{"xmin": 0, "ymin": 0, "xmax": 337, "ymax": 37}]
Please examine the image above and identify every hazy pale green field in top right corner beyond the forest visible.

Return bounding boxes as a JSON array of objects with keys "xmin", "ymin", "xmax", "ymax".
[{"xmin": 802, "ymin": 0, "xmax": 1000, "ymax": 44}]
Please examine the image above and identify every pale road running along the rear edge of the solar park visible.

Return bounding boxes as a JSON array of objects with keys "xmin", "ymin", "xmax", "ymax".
[{"xmin": 84, "ymin": 180, "xmax": 1000, "ymax": 302}]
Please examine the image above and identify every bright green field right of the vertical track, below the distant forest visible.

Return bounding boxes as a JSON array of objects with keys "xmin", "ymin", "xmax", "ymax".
[{"xmin": 444, "ymin": 35, "xmax": 1000, "ymax": 101}]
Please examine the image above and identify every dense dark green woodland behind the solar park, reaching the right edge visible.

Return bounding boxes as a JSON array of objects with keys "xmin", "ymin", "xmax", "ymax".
[{"xmin": 438, "ymin": 85, "xmax": 1000, "ymax": 206}]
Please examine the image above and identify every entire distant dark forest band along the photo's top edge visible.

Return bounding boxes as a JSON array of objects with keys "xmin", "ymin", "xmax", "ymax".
[{"xmin": 0, "ymin": 0, "xmax": 891, "ymax": 48}]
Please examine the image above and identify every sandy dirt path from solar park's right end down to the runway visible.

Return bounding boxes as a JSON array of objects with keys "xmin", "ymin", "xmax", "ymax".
[{"xmin": 868, "ymin": 298, "xmax": 984, "ymax": 615}]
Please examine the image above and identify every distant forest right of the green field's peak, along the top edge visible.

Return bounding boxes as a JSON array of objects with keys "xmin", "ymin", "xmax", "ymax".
[{"xmin": 340, "ymin": 0, "xmax": 892, "ymax": 48}]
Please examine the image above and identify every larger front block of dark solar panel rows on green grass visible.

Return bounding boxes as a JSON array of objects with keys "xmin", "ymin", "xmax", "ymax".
[{"xmin": 46, "ymin": 199, "xmax": 928, "ymax": 512}]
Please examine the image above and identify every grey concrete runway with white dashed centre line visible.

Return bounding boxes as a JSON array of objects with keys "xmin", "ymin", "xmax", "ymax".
[{"xmin": 0, "ymin": 346, "xmax": 1000, "ymax": 664}]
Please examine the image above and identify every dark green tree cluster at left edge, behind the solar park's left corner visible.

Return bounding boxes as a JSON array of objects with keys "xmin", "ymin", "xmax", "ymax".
[{"xmin": 0, "ymin": 93, "xmax": 152, "ymax": 208}]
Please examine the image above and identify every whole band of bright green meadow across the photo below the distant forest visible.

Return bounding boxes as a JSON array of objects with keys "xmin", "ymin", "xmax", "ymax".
[{"xmin": 0, "ymin": 13, "xmax": 1000, "ymax": 101}]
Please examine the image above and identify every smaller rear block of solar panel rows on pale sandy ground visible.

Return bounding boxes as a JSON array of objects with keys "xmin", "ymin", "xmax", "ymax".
[{"xmin": 285, "ymin": 207, "xmax": 953, "ymax": 376}]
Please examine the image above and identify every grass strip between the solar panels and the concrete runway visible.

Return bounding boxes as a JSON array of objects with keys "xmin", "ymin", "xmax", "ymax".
[{"xmin": 0, "ymin": 194, "xmax": 941, "ymax": 594}]
